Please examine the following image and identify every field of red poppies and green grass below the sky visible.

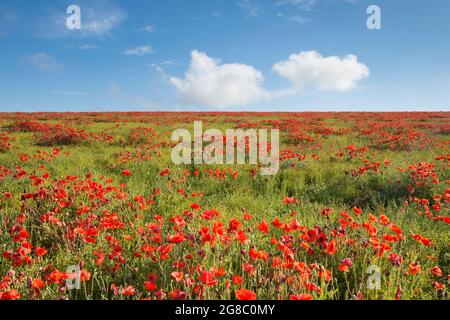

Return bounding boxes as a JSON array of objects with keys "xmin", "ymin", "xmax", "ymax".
[{"xmin": 0, "ymin": 112, "xmax": 450, "ymax": 300}]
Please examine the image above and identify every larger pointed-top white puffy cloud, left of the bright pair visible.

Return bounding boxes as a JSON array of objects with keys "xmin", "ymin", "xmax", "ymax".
[{"xmin": 170, "ymin": 50, "xmax": 268, "ymax": 108}]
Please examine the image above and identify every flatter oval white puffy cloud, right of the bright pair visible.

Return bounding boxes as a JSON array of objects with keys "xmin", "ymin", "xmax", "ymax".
[{"xmin": 272, "ymin": 51, "xmax": 369, "ymax": 91}]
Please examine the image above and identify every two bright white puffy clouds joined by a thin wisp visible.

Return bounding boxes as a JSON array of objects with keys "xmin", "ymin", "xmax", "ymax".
[{"xmin": 169, "ymin": 50, "xmax": 369, "ymax": 108}]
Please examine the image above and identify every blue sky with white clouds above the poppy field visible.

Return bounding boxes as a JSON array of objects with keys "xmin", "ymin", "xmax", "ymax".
[{"xmin": 0, "ymin": 0, "xmax": 450, "ymax": 112}]
